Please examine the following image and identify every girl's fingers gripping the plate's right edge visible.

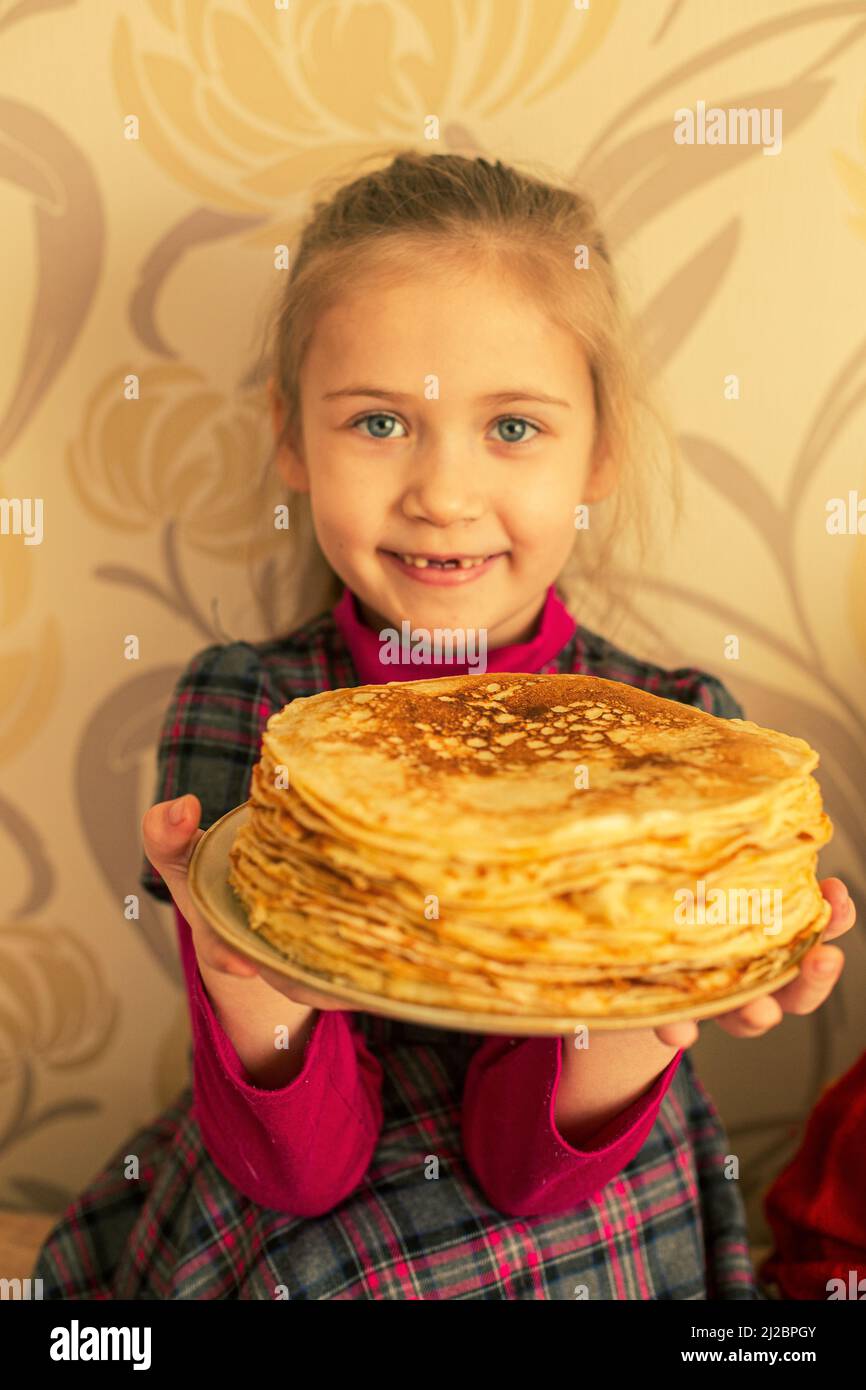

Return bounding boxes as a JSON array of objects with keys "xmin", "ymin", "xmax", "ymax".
[{"xmin": 655, "ymin": 878, "xmax": 856, "ymax": 1047}]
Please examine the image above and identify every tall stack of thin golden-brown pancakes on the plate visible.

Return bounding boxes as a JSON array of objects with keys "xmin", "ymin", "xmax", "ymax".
[{"xmin": 229, "ymin": 673, "xmax": 833, "ymax": 1020}]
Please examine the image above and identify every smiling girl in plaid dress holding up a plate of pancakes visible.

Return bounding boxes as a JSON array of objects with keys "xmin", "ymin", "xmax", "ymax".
[{"xmin": 35, "ymin": 152, "xmax": 853, "ymax": 1300}]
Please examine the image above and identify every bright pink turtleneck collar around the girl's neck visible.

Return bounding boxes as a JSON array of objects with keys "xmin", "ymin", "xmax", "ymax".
[{"xmin": 334, "ymin": 584, "xmax": 577, "ymax": 685}]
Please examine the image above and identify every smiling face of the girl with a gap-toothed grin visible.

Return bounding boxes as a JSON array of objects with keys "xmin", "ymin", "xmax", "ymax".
[{"xmin": 270, "ymin": 261, "xmax": 614, "ymax": 649}]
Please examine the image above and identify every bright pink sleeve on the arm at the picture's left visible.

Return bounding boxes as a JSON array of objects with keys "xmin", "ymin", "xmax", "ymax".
[{"xmin": 175, "ymin": 905, "xmax": 382, "ymax": 1216}]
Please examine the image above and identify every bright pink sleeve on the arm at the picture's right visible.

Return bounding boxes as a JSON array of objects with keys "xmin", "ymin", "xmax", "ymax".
[{"xmin": 461, "ymin": 1037, "xmax": 683, "ymax": 1216}]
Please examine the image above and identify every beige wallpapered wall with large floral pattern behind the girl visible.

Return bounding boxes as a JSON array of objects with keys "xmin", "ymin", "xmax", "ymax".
[{"xmin": 0, "ymin": 0, "xmax": 866, "ymax": 1238}]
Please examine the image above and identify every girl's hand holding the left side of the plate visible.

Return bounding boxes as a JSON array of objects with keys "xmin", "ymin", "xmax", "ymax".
[{"xmin": 142, "ymin": 792, "xmax": 348, "ymax": 1009}]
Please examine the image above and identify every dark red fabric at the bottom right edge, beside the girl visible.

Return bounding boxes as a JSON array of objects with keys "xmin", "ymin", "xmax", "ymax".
[{"xmin": 759, "ymin": 1052, "xmax": 866, "ymax": 1300}]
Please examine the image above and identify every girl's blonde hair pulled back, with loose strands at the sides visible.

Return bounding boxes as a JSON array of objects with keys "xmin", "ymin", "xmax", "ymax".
[{"xmin": 250, "ymin": 149, "xmax": 681, "ymax": 636}]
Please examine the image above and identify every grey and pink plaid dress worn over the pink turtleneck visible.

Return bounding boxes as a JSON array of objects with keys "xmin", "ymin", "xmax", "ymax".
[{"xmin": 33, "ymin": 613, "xmax": 766, "ymax": 1300}]
